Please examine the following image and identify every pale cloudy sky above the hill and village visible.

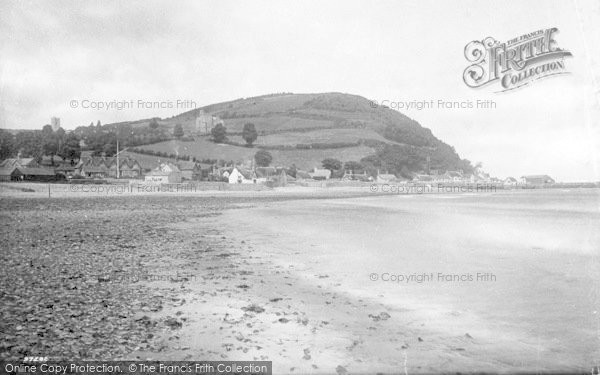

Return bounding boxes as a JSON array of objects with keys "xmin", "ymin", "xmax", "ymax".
[{"xmin": 0, "ymin": 0, "xmax": 600, "ymax": 181}]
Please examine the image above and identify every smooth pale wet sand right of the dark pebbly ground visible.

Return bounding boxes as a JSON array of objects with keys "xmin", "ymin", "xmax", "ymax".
[{"xmin": 151, "ymin": 191, "xmax": 600, "ymax": 373}]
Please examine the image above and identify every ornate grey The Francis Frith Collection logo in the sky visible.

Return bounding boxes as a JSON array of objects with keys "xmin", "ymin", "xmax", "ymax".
[{"xmin": 463, "ymin": 28, "xmax": 572, "ymax": 92}]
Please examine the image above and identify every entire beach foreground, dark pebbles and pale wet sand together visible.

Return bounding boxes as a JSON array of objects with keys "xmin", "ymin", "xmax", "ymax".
[{"xmin": 0, "ymin": 189, "xmax": 600, "ymax": 374}]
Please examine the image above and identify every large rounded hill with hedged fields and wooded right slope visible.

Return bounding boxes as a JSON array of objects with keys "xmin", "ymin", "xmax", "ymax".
[{"xmin": 118, "ymin": 93, "xmax": 472, "ymax": 174}]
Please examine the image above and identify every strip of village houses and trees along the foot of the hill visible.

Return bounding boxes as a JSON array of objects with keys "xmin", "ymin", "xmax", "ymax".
[{"xmin": 0, "ymin": 151, "xmax": 555, "ymax": 189}]
